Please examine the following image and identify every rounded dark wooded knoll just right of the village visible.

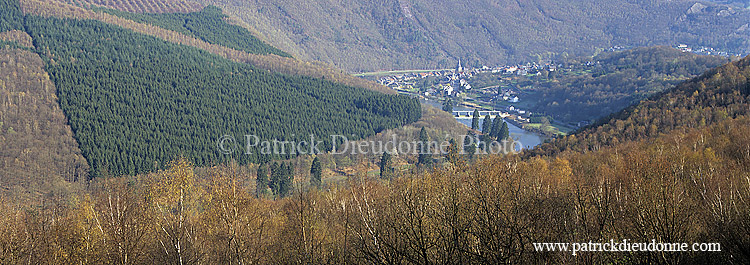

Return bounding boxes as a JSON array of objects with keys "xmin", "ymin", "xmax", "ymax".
[{"xmin": 529, "ymin": 47, "xmax": 728, "ymax": 122}]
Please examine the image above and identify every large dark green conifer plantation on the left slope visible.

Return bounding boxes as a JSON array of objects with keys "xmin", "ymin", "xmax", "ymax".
[{"xmin": 20, "ymin": 11, "xmax": 421, "ymax": 177}]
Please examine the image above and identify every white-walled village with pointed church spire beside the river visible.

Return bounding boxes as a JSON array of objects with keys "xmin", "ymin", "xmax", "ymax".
[{"xmin": 377, "ymin": 44, "xmax": 742, "ymax": 133}]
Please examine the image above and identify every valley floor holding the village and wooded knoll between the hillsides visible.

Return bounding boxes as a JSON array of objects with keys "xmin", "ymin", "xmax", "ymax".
[{"xmin": 374, "ymin": 45, "xmax": 738, "ymax": 140}]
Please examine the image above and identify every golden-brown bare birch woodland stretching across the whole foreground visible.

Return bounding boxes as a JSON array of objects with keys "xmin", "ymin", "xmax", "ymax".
[{"xmin": 0, "ymin": 59, "xmax": 750, "ymax": 264}]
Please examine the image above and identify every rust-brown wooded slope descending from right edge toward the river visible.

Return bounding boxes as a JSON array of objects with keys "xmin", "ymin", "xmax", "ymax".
[{"xmin": 528, "ymin": 54, "xmax": 750, "ymax": 155}]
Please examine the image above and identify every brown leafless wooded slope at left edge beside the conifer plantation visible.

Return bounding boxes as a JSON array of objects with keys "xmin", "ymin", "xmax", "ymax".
[{"xmin": 0, "ymin": 46, "xmax": 89, "ymax": 200}]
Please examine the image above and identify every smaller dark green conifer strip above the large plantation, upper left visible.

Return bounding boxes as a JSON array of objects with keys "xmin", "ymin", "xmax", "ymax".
[{"xmin": 94, "ymin": 6, "xmax": 290, "ymax": 57}]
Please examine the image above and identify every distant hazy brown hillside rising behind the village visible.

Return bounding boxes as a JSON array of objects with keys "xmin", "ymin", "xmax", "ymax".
[{"xmin": 196, "ymin": 0, "xmax": 750, "ymax": 72}]
